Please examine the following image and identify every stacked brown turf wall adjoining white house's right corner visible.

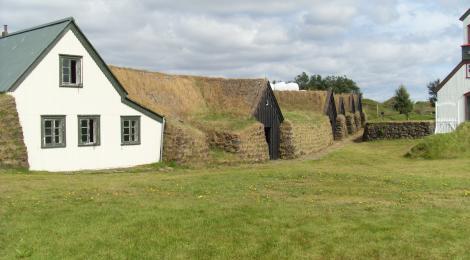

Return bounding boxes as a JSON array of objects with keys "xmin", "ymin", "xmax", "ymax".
[{"xmin": 163, "ymin": 121, "xmax": 209, "ymax": 164}]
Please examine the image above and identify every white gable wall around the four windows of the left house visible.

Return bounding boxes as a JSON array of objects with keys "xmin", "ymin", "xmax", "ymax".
[{"xmin": 11, "ymin": 31, "xmax": 162, "ymax": 171}]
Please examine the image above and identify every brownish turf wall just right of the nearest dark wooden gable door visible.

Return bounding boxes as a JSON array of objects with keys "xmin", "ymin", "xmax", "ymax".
[{"xmin": 280, "ymin": 116, "xmax": 333, "ymax": 159}]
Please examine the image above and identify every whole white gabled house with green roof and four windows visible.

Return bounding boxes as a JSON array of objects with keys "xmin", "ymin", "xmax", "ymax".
[{"xmin": 0, "ymin": 18, "xmax": 164, "ymax": 171}]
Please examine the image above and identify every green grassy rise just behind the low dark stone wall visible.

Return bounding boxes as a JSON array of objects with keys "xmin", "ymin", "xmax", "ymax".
[{"xmin": 362, "ymin": 99, "xmax": 434, "ymax": 121}]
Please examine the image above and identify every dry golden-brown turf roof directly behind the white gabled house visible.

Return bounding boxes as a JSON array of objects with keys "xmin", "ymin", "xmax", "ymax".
[{"xmin": 110, "ymin": 66, "xmax": 267, "ymax": 128}]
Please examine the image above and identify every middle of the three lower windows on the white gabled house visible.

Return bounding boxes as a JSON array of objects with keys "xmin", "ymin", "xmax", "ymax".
[{"xmin": 78, "ymin": 116, "xmax": 100, "ymax": 146}]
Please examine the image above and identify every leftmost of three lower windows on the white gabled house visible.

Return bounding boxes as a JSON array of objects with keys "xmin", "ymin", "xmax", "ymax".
[{"xmin": 41, "ymin": 116, "xmax": 65, "ymax": 148}]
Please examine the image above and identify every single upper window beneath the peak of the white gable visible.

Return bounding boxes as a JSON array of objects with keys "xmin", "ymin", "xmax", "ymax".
[{"xmin": 60, "ymin": 55, "xmax": 82, "ymax": 87}]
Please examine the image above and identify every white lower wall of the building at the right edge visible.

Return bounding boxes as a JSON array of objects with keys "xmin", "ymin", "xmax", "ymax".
[{"xmin": 436, "ymin": 65, "xmax": 470, "ymax": 133}]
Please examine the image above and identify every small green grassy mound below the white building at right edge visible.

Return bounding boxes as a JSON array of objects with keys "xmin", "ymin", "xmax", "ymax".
[{"xmin": 407, "ymin": 123, "xmax": 470, "ymax": 159}]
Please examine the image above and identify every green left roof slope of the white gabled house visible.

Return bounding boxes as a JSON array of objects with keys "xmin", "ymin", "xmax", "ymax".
[{"xmin": 0, "ymin": 18, "xmax": 73, "ymax": 92}]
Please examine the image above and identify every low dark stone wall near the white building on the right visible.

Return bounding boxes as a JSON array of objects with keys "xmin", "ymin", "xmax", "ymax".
[{"xmin": 362, "ymin": 121, "xmax": 435, "ymax": 141}]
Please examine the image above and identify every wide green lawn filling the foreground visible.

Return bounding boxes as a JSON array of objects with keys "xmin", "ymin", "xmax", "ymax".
[{"xmin": 0, "ymin": 141, "xmax": 470, "ymax": 259}]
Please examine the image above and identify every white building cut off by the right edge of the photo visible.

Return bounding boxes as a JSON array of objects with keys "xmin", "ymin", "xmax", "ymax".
[{"xmin": 436, "ymin": 9, "xmax": 470, "ymax": 133}]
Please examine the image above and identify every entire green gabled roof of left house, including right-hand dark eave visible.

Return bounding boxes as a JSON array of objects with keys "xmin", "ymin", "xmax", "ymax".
[{"xmin": 0, "ymin": 17, "xmax": 163, "ymax": 122}]
